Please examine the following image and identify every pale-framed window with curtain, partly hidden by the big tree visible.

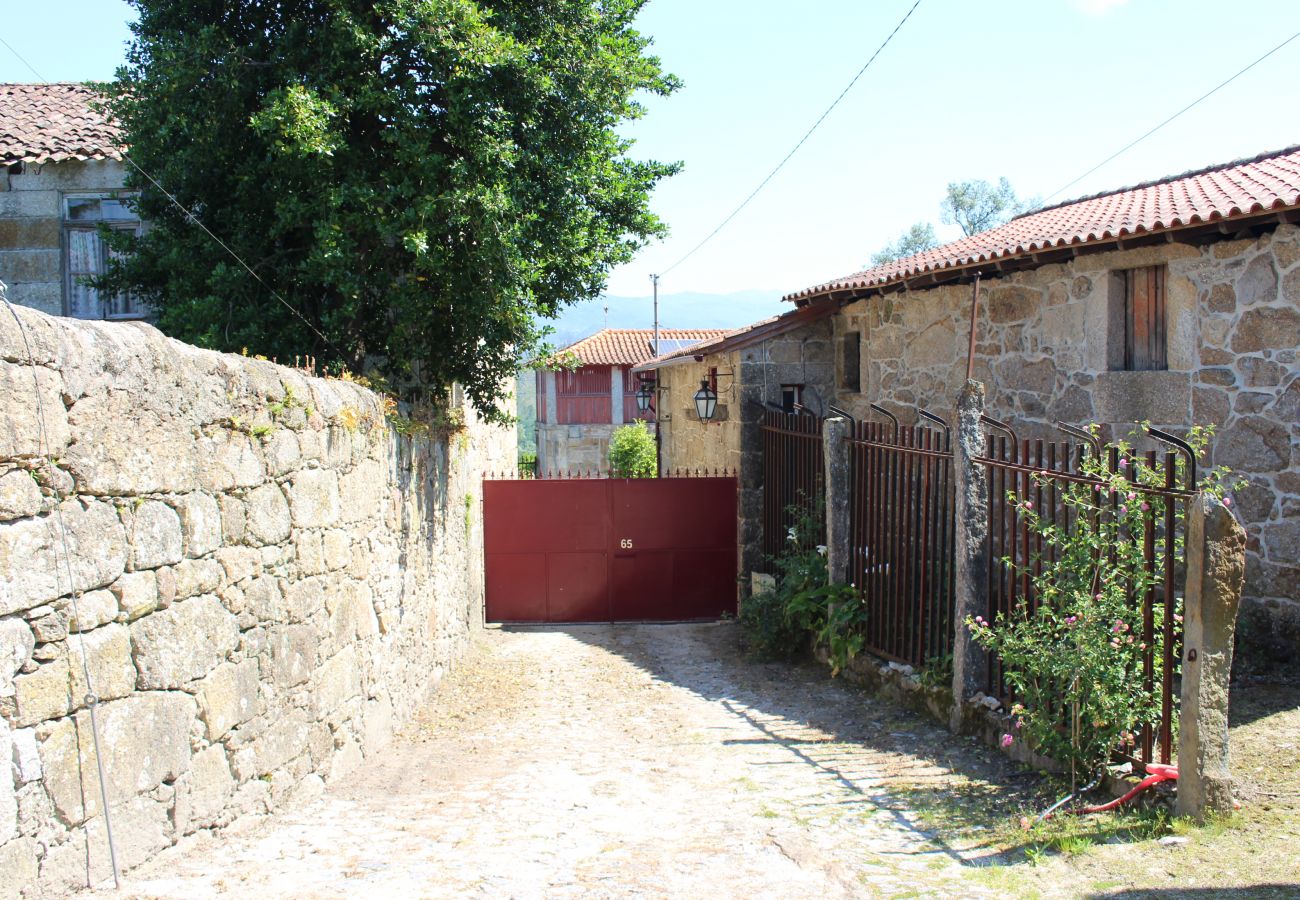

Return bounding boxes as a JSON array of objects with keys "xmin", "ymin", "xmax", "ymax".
[{"xmin": 64, "ymin": 194, "xmax": 148, "ymax": 319}]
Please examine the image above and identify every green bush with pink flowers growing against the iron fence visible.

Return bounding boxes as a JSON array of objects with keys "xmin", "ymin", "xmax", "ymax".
[{"xmin": 966, "ymin": 427, "xmax": 1230, "ymax": 776}]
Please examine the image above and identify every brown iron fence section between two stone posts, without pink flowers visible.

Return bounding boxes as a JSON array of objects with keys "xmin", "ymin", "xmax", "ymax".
[{"xmin": 848, "ymin": 421, "xmax": 956, "ymax": 666}]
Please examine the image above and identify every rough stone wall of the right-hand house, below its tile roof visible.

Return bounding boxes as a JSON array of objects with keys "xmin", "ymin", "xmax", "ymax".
[{"xmin": 835, "ymin": 225, "xmax": 1300, "ymax": 653}]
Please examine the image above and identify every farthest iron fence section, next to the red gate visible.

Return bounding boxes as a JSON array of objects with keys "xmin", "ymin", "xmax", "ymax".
[{"xmin": 762, "ymin": 410, "xmax": 826, "ymax": 559}]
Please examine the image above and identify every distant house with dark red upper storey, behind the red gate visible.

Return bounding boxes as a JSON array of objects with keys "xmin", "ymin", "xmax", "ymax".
[{"xmin": 537, "ymin": 328, "xmax": 725, "ymax": 471}]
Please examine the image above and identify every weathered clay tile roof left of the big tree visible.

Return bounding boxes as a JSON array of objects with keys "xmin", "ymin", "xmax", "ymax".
[{"xmin": 0, "ymin": 83, "xmax": 122, "ymax": 165}]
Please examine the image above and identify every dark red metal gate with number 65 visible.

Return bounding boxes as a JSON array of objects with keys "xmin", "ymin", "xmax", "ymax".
[{"xmin": 484, "ymin": 477, "xmax": 737, "ymax": 623}]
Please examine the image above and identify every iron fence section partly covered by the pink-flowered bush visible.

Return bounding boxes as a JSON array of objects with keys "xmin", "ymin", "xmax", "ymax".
[{"xmin": 978, "ymin": 429, "xmax": 1195, "ymax": 763}]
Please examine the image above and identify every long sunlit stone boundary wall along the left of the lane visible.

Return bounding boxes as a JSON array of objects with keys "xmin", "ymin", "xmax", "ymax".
[{"xmin": 0, "ymin": 308, "xmax": 515, "ymax": 896}]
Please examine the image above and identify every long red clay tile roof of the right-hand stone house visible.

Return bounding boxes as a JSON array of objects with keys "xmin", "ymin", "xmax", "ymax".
[{"xmin": 785, "ymin": 146, "xmax": 1300, "ymax": 300}]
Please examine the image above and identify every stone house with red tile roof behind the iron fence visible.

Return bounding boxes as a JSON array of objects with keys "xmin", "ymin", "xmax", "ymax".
[{"xmin": 639, "ymin": 147, "xmax": 1300, "ymax": 652}]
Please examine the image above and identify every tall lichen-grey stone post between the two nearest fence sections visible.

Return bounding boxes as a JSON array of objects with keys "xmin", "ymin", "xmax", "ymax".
[{"xmin": 948, "ymin": 381, "xmax": 989, "ymax": 732}]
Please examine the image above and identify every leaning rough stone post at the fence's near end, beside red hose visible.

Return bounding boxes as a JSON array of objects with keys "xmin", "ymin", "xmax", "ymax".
[{"xmin": 1175, "ymin": 497, "xmax": 1245, "ymax": 819}]
